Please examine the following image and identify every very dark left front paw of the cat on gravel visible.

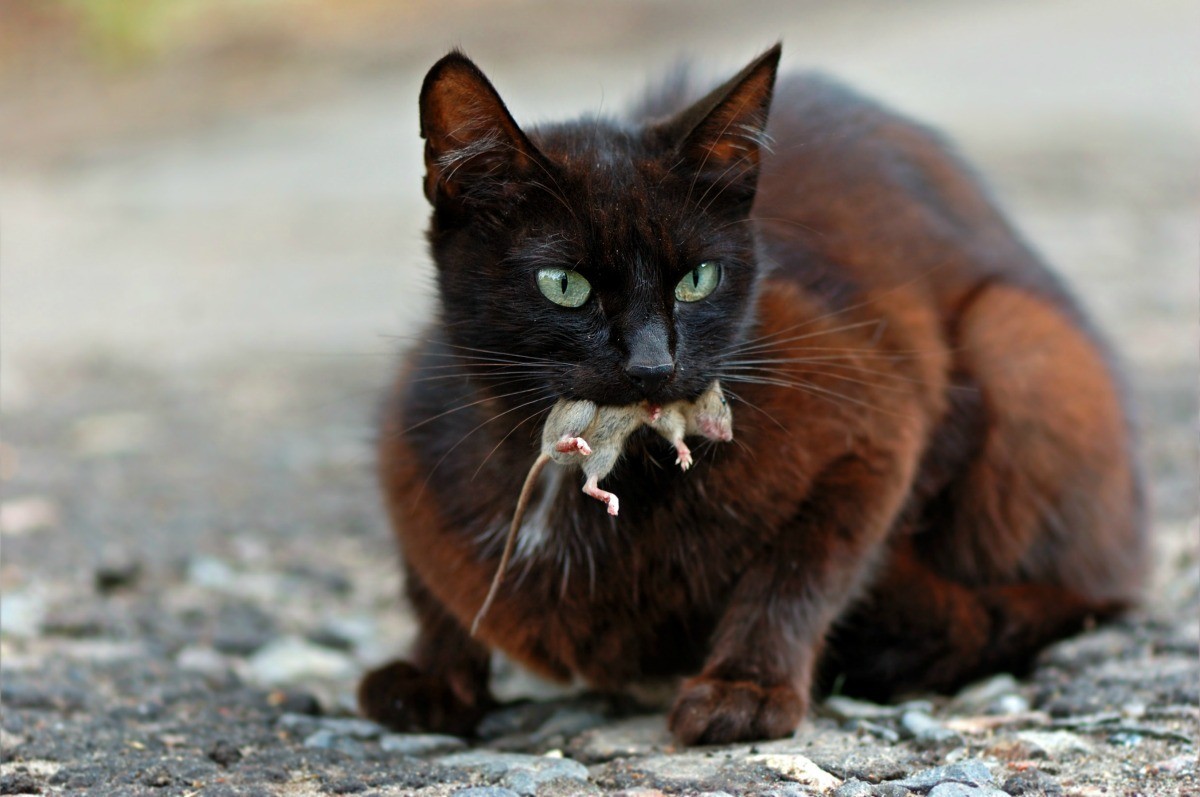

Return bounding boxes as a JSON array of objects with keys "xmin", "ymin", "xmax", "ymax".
[{"xmin": 359, "ymin": 661, "xmax": 493, "ymax": 736}]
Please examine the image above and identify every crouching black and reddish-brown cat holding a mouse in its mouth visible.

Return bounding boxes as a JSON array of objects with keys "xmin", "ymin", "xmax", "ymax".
[{"xmin": 359, "ymin": 46, "xmax": 1147, "ymax": 744}]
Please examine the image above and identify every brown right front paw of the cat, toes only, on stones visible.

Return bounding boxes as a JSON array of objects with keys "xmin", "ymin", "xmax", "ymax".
[{"xmin": 668, "ymin": 676, "xmax": 808, "ymax": 744}]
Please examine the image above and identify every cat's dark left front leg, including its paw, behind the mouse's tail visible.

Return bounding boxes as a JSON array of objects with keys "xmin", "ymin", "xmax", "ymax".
[{"xmin": 358, "ymin": 570, "xmax": 496, "ymax": 736}]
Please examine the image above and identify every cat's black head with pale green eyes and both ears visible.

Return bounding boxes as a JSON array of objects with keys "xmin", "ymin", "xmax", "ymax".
[{"xmin": 420, "ymin": 46, "xmax": 780, "ymax": 405}]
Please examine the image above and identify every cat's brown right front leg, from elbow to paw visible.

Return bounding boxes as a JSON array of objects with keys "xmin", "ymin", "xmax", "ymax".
[{"xmin": 670, "ymin": 453, "xmax": 913, "ymax": 744}]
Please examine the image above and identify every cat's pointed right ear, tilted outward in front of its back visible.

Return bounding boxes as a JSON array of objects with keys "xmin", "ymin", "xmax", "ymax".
[{"xmin": 666, "ymin": 44, "xmax": 781, "ymax": 191}]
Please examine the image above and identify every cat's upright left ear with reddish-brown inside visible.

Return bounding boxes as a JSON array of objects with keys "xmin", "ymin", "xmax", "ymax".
[{"xmin": 420, "ymin": 50, "xmax": 540, "ymax": 204}]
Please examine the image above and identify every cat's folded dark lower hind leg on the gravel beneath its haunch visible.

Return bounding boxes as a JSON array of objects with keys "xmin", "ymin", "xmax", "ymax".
[{"xmin": 822, "ymin": 540, "xmax": 1124, "ymax": 700}]
